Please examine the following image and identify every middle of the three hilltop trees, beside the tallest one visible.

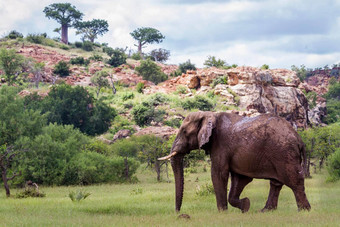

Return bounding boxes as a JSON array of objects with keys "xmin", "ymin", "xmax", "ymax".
[{"xmin": 75, "ymin": 19, "xmax": 109, "ymax": 43}]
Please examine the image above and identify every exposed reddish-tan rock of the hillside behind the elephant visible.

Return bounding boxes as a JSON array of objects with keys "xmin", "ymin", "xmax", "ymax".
[{"xmin": 1, "ymin": 41, "xmax": 329, "ymax": 140}]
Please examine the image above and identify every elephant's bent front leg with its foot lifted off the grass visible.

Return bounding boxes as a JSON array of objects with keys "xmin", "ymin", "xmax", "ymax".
[{"xmin": 229, "ymin": 173, "xmax": 253, "ymax": 213}]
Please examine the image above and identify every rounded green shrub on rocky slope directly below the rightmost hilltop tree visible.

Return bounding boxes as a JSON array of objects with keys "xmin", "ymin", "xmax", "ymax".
[{"xmin": 135, "ymin": 59, "xmax": 168, "ymax": 84}]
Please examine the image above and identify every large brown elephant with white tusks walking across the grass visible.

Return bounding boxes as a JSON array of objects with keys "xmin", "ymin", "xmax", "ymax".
[{"xmin": 159, "ymin": 111, "xmax": 311, "ymax": 212}]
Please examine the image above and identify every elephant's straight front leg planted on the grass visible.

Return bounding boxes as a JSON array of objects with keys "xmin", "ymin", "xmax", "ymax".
[{"xmin": 211, "ymin": 162, "xmax": 229, "ymax": 211}]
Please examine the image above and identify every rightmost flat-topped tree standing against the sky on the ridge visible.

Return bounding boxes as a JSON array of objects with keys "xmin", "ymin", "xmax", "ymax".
[{"xmin": 130, "ymin": 27, "xmax": 165, "ymax": 54}]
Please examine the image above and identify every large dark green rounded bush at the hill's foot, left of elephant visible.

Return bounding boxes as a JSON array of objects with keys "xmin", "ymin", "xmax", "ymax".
[{"xmin": 26, "ymin": 85, "xmax": 117, "ymax": 135}]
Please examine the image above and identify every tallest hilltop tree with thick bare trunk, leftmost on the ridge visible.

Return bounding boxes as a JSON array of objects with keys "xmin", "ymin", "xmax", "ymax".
[{"xmin": 43, "ymin": 3, "xmax": 83, "ymax": 44}]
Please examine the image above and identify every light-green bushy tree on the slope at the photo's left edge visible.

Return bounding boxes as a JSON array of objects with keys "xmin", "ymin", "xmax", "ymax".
[{"xmin": 0, "ymin": 49, "xmax": 24, "ymax": 85}]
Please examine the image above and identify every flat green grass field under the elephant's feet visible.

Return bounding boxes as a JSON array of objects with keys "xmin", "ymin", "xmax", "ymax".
[{"xmin": 0, "ymin": 166, "xmax": 340, "ymax": 226}]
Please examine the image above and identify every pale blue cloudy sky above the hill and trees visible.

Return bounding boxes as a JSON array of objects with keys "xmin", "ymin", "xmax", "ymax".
[{"xmin": 0, "ymin": 0, "xmax": 340, "ymax": 69}]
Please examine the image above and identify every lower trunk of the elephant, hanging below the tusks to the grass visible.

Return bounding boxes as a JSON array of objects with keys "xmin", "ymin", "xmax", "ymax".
[{"xmin": 171, "ymin": 155, "xmax": 184, "ymax": 212}]
